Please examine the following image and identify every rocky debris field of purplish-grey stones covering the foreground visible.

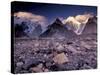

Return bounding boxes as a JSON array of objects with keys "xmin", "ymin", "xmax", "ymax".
[{"xmin": 14, "ymin": 36, "xmax": 97, "ymax": 73}]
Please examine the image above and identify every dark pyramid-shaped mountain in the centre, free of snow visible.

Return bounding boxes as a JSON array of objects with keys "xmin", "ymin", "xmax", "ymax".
[{"xmin": 40, "ymin": 18, "xmax": 76, "ymax": 38}]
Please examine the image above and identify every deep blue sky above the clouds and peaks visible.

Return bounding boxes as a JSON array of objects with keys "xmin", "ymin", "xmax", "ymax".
[{"xmin": 11, "ymin": 2, "xmax": 97, "ymax": 22}]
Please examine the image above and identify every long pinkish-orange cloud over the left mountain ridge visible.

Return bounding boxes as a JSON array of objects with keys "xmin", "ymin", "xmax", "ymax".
[{"xmin": 14, "ymin": 12, "xmax": 47, "ymax": 25}]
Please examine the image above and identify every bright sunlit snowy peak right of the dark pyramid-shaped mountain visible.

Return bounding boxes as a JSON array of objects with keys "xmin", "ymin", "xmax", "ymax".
[{"xmin": 63, "ymin": 14, "xmax": 94, "ymax": 35}]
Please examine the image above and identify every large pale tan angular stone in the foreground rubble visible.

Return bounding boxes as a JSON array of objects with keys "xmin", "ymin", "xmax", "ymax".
[{"xmin": 53, "ymin": 53, "xmax": 69, "ymax": 64}]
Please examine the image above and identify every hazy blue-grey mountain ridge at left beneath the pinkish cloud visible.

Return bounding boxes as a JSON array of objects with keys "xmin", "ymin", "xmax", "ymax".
[{"xmin": 13, "ymin": 16, "xmax": 42, "ymax": 37}]
